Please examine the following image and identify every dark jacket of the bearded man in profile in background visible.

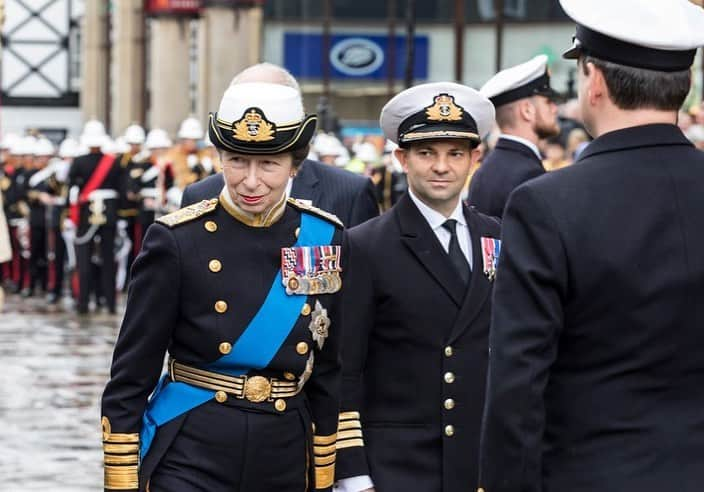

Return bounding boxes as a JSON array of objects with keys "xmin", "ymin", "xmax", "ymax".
[{"xmin": 467, "ymin": 138, "xmax": 545, "ymax": 217}]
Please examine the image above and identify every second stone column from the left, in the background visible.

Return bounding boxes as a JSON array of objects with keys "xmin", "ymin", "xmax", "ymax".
[{"xmin": 110, "ymin": 0, "xmax": 146, "ymax": 135}]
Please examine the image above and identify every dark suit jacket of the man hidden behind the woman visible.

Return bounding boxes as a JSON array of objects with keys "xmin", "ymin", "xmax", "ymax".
[{"xmin": 181, "ymin": 159, "xmax": 379, "ymax": 227}]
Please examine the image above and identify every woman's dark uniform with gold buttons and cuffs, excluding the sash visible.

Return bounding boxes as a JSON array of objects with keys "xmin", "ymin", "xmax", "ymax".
[{"xmin": 102, "ymin": 199, "xmax": 342, "ymax": 492}]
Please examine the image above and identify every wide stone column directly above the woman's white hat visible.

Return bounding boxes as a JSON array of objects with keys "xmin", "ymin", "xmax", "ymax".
[{"xmin": 197, "ymin": 6, "xmax": 263, "ymax": 123}]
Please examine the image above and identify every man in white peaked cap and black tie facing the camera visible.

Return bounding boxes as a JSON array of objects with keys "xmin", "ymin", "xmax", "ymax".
[{"xmin": 337, "ymin": 82, "xmax": 500, "ymax": 492}]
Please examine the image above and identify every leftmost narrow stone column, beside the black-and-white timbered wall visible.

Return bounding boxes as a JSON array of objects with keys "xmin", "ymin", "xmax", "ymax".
[{"xmin": 81, "ymin": 2, "xmax": 110, "ymax": 127}]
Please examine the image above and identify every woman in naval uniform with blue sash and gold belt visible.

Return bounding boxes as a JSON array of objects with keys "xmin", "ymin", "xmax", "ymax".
[{"xmin": 102, "ymin": 83, "xmax": 342, "ymax": 492}]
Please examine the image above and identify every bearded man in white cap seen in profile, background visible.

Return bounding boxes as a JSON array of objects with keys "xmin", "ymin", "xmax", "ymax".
[{"xmin": 468, "ymin": 55, "xmax": 560, "ymax": 217}]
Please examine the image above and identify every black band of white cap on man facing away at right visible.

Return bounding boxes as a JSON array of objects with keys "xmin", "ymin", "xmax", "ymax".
[{"xmin": 564, "ymin": 24, "xmax": 697, "ymax": 72}]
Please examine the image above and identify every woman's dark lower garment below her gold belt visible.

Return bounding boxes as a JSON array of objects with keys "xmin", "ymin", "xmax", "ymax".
[{"xmin": 147, "ymin": 401, "xmax": 313, "ymax": 492}]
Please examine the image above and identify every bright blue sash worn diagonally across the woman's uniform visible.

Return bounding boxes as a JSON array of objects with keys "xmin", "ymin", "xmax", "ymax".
[{"xmin": 139, "ymin": 212, "xmax": 335, "ymax": 460}]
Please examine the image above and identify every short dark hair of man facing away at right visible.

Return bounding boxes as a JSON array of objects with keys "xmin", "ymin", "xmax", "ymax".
[{"xmin": 580, "ymin": 55, "xmax": 692, "ymax": 111}]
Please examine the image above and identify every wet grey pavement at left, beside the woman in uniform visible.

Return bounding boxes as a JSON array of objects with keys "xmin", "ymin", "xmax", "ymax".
[{"xmin": 0, "ymin": 290, "xmax": 120, "ymax": 492}]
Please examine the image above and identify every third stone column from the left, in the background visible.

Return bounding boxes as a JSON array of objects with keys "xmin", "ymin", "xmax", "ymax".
[{"xmin": 149, "ymin": 16, "xmax": 190, "ymax": 139}]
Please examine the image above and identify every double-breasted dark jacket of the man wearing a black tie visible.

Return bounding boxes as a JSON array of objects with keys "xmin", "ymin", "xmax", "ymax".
[{"xmin": 337, "ymin": 195, "xmax": 499, "ymax": 492}]
